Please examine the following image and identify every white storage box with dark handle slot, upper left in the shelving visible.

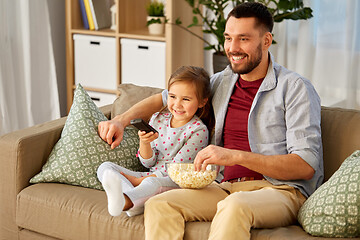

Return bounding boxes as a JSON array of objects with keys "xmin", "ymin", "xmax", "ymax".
[{"xmin": 73, "ymin": 34, "xmax": 117, "ymax": 90}]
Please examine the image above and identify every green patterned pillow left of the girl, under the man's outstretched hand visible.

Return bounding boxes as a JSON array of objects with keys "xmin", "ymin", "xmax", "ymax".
[{"xmin": 30, "ymin": 84, "xmax": 146, "ymax": 190}]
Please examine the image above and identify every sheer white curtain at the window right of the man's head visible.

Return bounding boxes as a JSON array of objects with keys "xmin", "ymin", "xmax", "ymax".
[{"xmin": 270, "ymin": 0, "xmax": 360, "ymax": 109}]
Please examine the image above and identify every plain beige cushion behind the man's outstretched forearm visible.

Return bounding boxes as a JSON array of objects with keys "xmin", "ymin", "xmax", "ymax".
[{"xmin": 111, "ymin": 83, "xmax": 163, "ymax": 118}]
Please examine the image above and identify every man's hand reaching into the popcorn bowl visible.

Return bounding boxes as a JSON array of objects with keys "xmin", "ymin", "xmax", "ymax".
[{"xmin": 194, "ymin": 145, "xmax": 234, "ymax": 171}]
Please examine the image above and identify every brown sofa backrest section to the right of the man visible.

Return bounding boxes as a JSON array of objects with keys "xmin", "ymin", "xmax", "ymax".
[{"xmin": 321, "ymin": 107, "xmax": 360, "ymax": 181}]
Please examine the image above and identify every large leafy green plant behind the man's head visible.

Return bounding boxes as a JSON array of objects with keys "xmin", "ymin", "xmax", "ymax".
[{"xmin": 172, "ymin": 0, "xmax": 312, "ymax": 72}]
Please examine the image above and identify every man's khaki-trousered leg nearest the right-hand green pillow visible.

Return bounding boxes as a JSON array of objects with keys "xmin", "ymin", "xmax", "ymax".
[{"xmin": 209, "ymin": 181, "xmax": 305, "ymax": 240}]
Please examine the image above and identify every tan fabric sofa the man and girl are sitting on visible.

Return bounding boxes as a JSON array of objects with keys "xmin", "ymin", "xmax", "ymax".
[{"xmin": 0, "ymin": 84, "xmax": 360, "ymax": 240}]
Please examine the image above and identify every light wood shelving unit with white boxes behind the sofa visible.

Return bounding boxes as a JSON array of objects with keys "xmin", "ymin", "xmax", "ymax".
[{"xmin": 66, "ymin": 0, "xmax": 204, "ymax": 111}]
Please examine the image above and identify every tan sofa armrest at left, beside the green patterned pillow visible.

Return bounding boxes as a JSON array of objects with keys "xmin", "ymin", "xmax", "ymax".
[{"xmin": 0, "ymin": 105, "xmax": 111, "ymax": 239}]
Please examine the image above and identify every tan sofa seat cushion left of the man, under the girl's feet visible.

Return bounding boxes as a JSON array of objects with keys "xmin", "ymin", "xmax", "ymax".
[{"xmin": 16, "ymin": 183, "xmax": 144, "ymax": 240}]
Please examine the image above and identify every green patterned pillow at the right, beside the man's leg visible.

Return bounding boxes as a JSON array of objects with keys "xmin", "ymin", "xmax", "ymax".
[{"xmin": 298, "ymin": 150, "xmax": 360, "ymax": 237}]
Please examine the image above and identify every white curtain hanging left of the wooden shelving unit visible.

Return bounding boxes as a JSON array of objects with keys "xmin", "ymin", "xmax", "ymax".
[{"xmin": 0, "ymin": 0, "xmax": 60, "ymax": 135}]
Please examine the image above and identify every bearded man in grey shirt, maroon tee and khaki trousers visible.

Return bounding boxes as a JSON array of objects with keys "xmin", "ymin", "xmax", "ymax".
[{"xmin": 99, "ymin": 3, "xmax": 323, "ymax": 240}]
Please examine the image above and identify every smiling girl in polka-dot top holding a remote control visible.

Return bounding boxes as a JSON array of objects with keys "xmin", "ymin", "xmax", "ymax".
[{"xmin": 97, "ymin": 66, "xmax": 213, "ymax": 216}]
